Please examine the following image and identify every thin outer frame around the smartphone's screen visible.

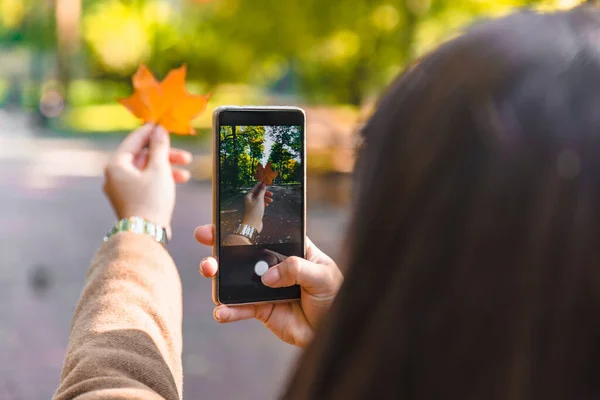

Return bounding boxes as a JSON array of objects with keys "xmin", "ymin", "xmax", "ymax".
[{"xmin": 212, "ymin": 106, "xmax": 306, "ymax": 305}]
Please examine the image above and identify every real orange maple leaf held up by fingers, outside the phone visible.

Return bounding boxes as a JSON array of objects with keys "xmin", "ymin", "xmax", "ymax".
[{"xmin": 119, "ymin": 65, "xmax": 210, "ymax": 135}]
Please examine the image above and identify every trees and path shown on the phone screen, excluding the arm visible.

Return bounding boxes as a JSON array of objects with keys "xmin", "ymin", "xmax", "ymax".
[{"xmin": 219, "ymin": 126, "xmax": 304, "ymax": 245}]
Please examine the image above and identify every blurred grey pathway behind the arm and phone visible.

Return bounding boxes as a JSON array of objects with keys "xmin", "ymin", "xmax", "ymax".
[{"xmin": 0, "ymin": 110, "xmax": 346, "ymax": 400}]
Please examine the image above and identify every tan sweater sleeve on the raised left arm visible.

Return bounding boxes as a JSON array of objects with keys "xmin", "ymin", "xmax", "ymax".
[{"xmin": 54, "ymin": 233, "xmax": 183, "ymax": 400}]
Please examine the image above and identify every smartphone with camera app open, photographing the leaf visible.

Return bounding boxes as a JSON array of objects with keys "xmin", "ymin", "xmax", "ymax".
[{"xmin": 213, "ymin": 106, "xmax": 306, "ymax": 305}]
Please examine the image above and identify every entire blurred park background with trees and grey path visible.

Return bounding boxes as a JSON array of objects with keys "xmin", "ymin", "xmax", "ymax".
[{"xmin": 0, "ymin": 0, "xmax": 580, "ymax": 400}]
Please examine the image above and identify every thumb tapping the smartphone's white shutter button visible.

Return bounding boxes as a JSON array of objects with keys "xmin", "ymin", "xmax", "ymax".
[{"xmin": 262, "ymin": 257, "xmax": 333, "ymax": 292}]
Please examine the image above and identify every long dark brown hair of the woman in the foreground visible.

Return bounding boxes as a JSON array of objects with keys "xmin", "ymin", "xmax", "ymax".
[{"xmin": 285, "ymin": 6, "xmax": 600, "ymax": 400}]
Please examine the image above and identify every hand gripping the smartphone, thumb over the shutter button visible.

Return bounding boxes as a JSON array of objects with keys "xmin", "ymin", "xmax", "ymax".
[{"xmin": 195, "ymin": 225, "xmax": 344, "ymax": 347}]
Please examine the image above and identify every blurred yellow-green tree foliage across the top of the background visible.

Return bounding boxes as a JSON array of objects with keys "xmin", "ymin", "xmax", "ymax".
[{"xmin": 0, "ymin": 0, "xmax": 582, "ymax": 105}]
